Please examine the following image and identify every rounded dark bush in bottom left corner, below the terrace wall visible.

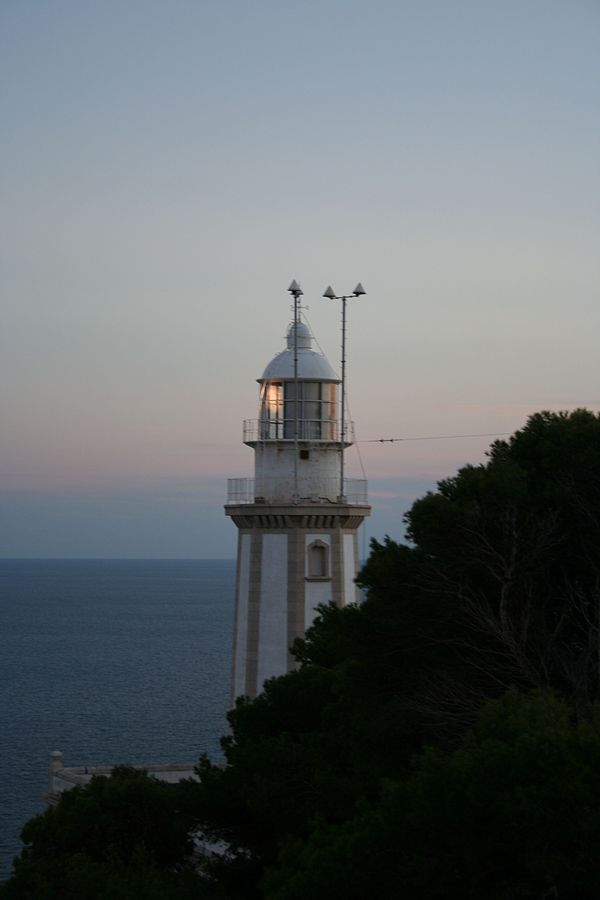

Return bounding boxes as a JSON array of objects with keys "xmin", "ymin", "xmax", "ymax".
[{"xmin": 0, "ymin": 766, "xmax": 217, "ymax": 900}]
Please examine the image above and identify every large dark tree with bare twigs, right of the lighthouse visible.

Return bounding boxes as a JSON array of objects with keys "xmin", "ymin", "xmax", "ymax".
[{"xmin": 360, "ymin": 410, "xmax": 600, "ymax": 724}]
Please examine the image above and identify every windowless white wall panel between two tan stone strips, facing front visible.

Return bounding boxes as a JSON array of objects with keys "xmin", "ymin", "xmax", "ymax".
[{"xmin": 257, "ymin": 534, "xmax": 288, "ymax": 689}]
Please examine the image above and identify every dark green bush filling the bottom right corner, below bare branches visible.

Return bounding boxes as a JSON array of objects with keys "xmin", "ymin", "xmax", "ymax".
[{"xmin": 264, "ymin": 692, "xmax": 600, "ymax": 900}]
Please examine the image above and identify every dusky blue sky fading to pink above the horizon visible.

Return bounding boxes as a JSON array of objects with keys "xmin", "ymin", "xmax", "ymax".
[{"xmin": 0, "ymin": 0, "xmax": 600, "ymax": 558}]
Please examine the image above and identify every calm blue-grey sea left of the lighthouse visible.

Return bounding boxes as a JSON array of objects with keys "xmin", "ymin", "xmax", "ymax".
[{"xmin": 0, "ymin": 560, "xmax": 235, "ymax": 879}]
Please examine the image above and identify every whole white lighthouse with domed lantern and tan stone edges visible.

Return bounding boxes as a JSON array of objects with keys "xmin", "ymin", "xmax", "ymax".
[{"xmin": 225, "ymin": 282, "xmax": 370, "ymax": 698}]
